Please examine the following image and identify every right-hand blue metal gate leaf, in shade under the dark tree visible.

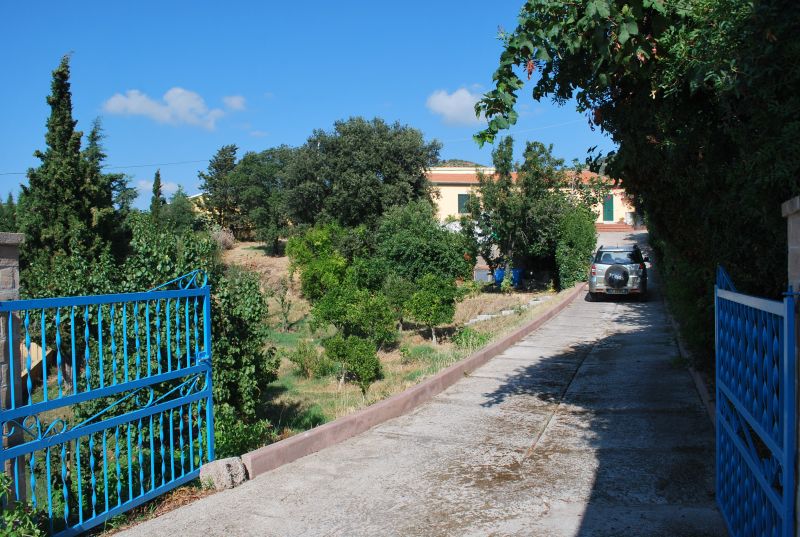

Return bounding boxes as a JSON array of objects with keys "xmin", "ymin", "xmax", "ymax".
[{"xmin": 715, "ymin": 268, "xmax": 797, "ymax": 537}]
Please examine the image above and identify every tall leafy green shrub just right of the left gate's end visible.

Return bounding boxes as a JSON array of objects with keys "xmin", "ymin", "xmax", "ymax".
[{"xmin": 212, "ymin": 269, "xmax": 279, "ymax": 422}]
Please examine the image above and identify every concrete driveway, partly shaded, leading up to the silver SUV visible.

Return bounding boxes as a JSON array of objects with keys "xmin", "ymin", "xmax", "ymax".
[{"xmin": 125, "ymin": 233, "xmax": 725, "ymax": 537}]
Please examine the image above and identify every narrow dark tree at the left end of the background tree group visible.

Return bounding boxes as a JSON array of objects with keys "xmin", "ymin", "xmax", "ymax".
[{"xmin": 198, "ymin": 144, "xmax": 239, "ymax": 230}]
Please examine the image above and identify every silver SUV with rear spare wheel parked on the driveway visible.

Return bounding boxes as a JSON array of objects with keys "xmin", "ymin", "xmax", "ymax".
[{"xmin": 589, "ymin": 245, "xmax": 649, "ymax": 300}]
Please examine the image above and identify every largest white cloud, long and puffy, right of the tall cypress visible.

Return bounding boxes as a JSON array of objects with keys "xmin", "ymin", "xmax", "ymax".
[{"xmin": 103, "ymin": 87, "xmax": 225, "ymax": 130}]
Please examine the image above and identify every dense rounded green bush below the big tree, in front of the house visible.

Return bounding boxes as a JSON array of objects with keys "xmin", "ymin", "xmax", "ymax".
[{"xmin": 376, "ymin": 200, "xmax": 475, "ymax": 280}]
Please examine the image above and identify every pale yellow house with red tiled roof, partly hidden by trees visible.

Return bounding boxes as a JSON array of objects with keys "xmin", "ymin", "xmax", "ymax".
[{"xmin": 428, "ymin": 167, "xmax": 636, "ymax": 229}]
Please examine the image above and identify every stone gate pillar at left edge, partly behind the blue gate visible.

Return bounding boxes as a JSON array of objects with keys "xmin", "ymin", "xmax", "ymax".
[{"xmin": 0, "ymin": 232, "xmax": 27, "ymax": 500}]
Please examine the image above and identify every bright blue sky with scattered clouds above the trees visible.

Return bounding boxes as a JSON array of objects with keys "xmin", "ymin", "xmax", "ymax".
[{"xmin": 0, "ymin": 0, "xmax": 612, "ymax": 206}]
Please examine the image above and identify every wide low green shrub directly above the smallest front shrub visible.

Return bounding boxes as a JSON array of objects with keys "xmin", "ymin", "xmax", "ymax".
[{"xmin": 311, "ymin": 283, "xmax": 397, "ymax": 347}]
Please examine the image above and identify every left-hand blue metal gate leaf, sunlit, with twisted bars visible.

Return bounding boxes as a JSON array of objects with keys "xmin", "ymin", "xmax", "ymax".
[{"xmin": 0, "ymin": 271, "xmax": 214, "ymax": 535}]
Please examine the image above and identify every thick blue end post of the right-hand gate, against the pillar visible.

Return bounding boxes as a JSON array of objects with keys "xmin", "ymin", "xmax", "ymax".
[{"xmin": 781, "ymin": 294, "xmax": 797, "ymax": 537}]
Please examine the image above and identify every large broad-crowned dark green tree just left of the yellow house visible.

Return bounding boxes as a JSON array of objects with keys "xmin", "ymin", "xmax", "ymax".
[{"xmin": 286, "ymin": 118, "xmax": 441, "ymax": 227}]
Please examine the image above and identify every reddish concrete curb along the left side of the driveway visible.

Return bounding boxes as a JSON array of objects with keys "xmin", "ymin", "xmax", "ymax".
[{"xmin": 242, "ymin": 283, "xmax": 586, "ymax": 479}]
